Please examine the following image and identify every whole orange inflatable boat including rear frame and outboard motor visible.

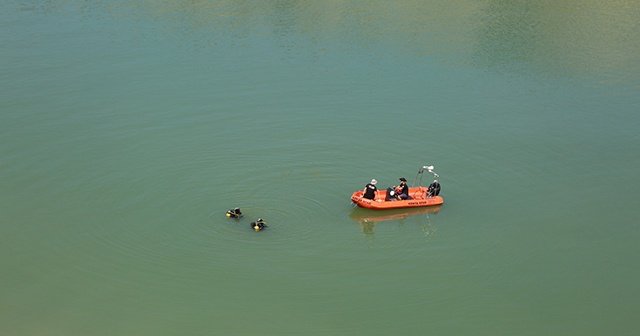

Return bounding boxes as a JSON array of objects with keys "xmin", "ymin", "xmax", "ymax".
[{"xmin": 351, "ymin": 166, "xmax": 444, "ymax": 210}]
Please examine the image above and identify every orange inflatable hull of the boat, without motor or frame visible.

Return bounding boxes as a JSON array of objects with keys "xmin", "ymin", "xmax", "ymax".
[{"xmin": 351, "ymin": 187, "xmax": 444, "ymax": 210}]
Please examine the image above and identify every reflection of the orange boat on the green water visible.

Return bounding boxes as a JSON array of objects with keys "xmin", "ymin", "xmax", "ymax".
[{"xmin": 349, "ymin": 205, "xmax": 442, "ymax": 235}]
